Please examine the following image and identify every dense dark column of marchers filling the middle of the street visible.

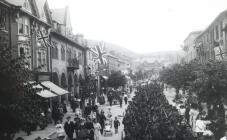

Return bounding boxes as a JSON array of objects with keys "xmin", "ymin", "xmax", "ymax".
[{"xmin": 123, "ymin": 81, "xmax": 194, "ymax": 140}]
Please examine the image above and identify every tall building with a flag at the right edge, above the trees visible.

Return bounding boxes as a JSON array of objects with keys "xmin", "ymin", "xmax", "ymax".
[{"xmin": 195, "ymin": 10, "xmax": 227, "ymax": 63}]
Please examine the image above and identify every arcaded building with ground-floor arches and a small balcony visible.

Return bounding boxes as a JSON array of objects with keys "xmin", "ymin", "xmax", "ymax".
[{"xmin": 50, "ymin": 7, "xmax": 86, "ymax": 98}]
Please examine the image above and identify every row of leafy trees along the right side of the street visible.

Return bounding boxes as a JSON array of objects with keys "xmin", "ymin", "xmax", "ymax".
[{"xmin": 159, "ymin": 61, "xmax": 227, "ymax": 104}]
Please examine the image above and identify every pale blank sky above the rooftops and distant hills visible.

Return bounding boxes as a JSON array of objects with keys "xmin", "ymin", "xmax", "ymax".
[{"xmin": 48, "ymin": 0, "xmax": 227, "ymax": 54}]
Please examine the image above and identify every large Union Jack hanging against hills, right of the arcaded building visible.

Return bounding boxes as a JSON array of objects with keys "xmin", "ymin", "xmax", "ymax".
[{"xmin": 91, "ymin": 42, "xmax": 107, "ymax": 65}]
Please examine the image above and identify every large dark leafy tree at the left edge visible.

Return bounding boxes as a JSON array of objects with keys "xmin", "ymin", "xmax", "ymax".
[{"xmin": 0, "ymin": 46, "xmax": 48, "ymax": 140}]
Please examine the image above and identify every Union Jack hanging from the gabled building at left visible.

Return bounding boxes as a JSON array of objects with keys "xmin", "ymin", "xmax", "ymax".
[{"xmin": 36, "ymin": 31, "xmax": 51, "ymax": 47}]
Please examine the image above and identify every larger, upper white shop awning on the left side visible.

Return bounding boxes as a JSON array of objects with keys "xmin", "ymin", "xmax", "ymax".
[{"xmin": 41, "ymin": 81, "xmax": 69, "ymax": 95}]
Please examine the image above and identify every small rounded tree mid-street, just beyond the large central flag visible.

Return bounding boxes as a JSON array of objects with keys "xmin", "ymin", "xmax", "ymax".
[{"xmin": 108, "ymin": 71, "xmax": 127, "ymax": 88}]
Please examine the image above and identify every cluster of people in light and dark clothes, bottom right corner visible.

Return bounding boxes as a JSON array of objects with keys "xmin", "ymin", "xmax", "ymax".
[{"xmin": 185, "ymin": 97, "xmax": 225, "ymax": 140}]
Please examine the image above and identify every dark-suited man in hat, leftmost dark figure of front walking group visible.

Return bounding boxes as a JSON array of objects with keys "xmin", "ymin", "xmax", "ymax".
[{"xmin": 64, "ymin": 116, "xmax": 74, "ymax": 140}]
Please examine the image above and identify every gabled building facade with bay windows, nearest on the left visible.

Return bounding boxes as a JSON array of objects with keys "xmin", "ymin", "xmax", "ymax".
[{"xmin": 2, "ymin": 0, "xmax": 52, "ymax": 78}]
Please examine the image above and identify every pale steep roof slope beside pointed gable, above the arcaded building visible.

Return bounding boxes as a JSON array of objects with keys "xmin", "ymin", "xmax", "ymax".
[{"xmin": 51, "ymin": 8, "xmax": 66, "ymax": 24}]
